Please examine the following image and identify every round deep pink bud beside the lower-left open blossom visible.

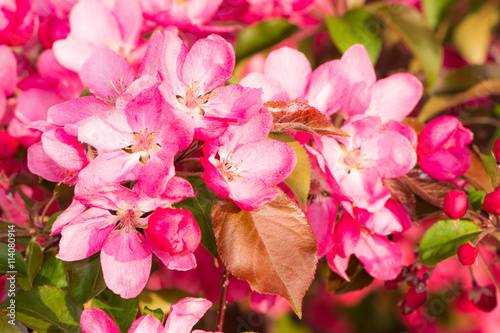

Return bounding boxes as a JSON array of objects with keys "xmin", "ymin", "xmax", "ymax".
[{"xmin": 145, "ymin": 208, "xmax": 201, "ymax": 255}]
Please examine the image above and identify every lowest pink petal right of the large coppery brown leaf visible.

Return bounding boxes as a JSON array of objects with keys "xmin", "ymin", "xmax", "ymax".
[{"xmin": 354, "ymin": 234, "xmax": 402, "ymax": 280}]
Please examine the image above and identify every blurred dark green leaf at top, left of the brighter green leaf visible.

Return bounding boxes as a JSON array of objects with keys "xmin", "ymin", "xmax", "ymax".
[{"xmin": 234, "ymin": 19, "xmax": 299, "ymax": 61}]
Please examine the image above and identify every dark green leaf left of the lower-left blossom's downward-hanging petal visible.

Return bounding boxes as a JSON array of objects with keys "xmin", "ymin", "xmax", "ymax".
[{"xmin": 64, "ymin": 253, "xmax": 106, "ymax": 303}]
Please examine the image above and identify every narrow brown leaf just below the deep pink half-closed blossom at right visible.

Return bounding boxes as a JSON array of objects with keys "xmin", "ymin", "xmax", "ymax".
[{"xmin": 399, "ymin": 169, "xmax": 462, "ymax": 208}]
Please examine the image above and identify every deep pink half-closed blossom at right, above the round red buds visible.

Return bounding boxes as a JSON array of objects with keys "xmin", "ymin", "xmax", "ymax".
[{"xmin": 417, "ymin": 116, "xmax": 473, "ymax": 180}]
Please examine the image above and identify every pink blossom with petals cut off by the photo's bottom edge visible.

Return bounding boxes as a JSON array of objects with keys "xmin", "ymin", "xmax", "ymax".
[{"xmin": 80, "ymin": 297, "xmax": 217, "ymax": 333}]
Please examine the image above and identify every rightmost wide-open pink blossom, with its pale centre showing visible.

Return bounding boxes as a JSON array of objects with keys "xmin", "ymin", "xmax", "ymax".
[{"xmin": 315, "ymin": 116, "xmax": 416, "ymax": 212}]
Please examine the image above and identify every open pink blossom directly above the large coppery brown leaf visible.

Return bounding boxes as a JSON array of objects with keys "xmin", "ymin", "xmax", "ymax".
[{"xmin": 200, "ymin": 109, "xmax": 297, "ymax": 210}]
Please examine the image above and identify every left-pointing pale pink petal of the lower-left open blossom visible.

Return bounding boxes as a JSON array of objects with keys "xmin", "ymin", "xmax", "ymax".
[{"xmin": 57, "ymin": 208, "xmax": 117, "ymax": 260}]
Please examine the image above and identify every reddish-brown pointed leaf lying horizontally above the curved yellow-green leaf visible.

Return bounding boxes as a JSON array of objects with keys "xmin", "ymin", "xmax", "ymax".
[{"xmin": 264, "ymin": 101, "xmax": 349, "ymax": 136}]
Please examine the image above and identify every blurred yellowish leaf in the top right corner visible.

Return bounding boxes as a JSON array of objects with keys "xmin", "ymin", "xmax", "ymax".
[{"xmin": 453, "ymin": 3, "xmax": 500, "ymax": 65}]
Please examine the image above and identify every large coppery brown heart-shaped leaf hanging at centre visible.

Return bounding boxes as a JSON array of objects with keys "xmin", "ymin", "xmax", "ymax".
[{"xmin": 212, "ymin": 192, "xmax": 318, "ymax": 317}]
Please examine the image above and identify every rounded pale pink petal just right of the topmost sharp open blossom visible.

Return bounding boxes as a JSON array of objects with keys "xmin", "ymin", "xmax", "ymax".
[{"xmin": 264, "ymin": 47, "xmax": 311, "ymax": 99}]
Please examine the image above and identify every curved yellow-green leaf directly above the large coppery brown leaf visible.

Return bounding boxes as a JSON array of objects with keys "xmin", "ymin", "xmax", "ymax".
[{"xmin": 269, "ymin": 133, "xmax": 311, "ymax": 210}]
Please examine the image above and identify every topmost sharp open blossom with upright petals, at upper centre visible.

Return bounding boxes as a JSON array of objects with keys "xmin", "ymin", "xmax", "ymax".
[{"xmin": 158, "ymin": 31, "xmax": 262, "ymax": 140}]
